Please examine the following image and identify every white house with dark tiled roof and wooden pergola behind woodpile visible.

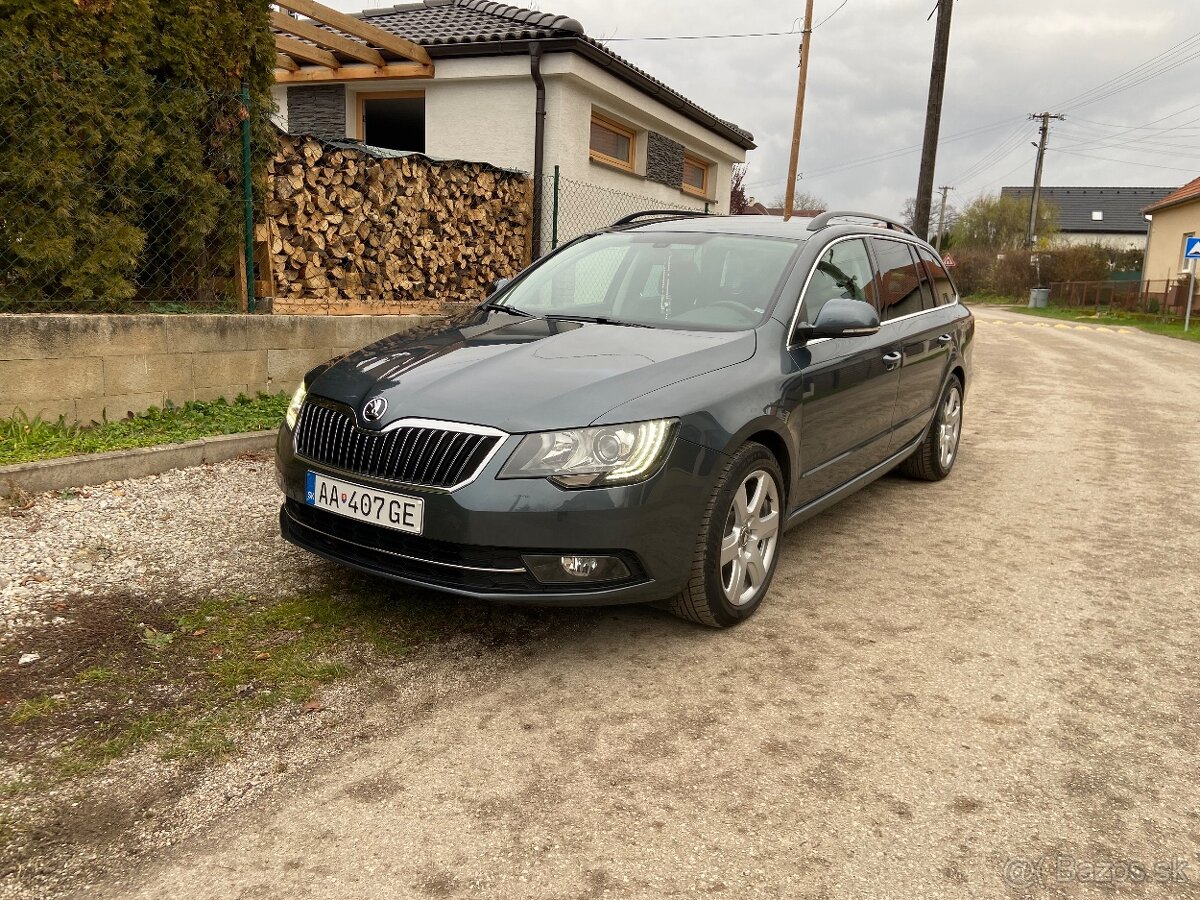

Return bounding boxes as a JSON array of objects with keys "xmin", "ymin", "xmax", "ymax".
[{"xmin": 272, "ymin": 0, "xmax": 755, "ymax": 250}]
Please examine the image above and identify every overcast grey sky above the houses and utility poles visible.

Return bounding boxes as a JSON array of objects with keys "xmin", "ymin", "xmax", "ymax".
[{"xmin": 336, "ymin": 0, "xmax": 1200, "ymax": 214}]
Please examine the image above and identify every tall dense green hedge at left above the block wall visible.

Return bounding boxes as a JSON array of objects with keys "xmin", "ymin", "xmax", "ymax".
[{"xmin": 0, "ymin": 0, "xmax": 275, "ymax": 311}]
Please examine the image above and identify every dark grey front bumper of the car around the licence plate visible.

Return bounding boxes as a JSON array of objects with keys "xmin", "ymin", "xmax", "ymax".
[{"xmin": 276, "ymin": 427, "xmax": 721, "ymax": 606}]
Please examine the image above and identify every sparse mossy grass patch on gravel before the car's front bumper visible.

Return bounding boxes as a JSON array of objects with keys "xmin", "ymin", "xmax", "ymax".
[{"xmin": 4, "ymin": 576, "xmax": 487, "ymax": 792}]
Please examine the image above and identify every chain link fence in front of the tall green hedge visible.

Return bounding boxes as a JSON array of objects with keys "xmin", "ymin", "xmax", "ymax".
[{"xmin": 0, "ymin": 59, "xmax": 270, "ymax": 312}]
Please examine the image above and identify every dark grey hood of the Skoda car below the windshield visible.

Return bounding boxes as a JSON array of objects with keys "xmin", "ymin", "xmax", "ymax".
[{"xmin": 310, "ymin": 312, "xmax": 755, "ymax": 433}]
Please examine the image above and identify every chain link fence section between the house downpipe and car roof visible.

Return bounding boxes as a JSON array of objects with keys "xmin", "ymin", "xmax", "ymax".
[{"xmin": 538, "ymin": 166, "xmax": 710, "ymax": 256}]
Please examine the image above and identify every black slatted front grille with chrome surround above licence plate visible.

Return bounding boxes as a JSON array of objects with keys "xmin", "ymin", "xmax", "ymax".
[{"xmin": 295, "ymin": 401, "xmax": 500, "ymax": 488}]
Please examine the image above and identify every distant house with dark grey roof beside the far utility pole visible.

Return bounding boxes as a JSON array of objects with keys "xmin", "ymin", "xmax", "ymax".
[{"xmin": 1000, "ymin": 187, "xmax": 1163, "ymax": 250}]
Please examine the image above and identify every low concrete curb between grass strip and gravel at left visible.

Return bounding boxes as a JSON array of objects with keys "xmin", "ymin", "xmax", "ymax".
[{"xmin": 0, "ymin": 430, "xmax": 278, "ymax": 497}]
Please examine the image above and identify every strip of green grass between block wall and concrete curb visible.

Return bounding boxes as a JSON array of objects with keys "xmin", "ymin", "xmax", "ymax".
[{"xmin": 0, "ymin": 394, "xmax": 289, "ymax": 466}]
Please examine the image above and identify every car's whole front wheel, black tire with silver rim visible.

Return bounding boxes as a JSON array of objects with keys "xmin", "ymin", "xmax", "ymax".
[{"xmin": 667, "ymin": 443, "xmax": 786, "ymax": 628}]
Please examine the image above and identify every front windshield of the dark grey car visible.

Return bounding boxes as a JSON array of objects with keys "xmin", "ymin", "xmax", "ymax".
[{"xmin": 497, "ymin": 232, "xmax": 799, "ymax": 331}]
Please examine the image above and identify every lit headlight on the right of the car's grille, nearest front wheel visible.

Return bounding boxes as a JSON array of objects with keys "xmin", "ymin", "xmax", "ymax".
[{"xmin": 498, "ymin": 419, "xmax": 678, "ymax": 487}]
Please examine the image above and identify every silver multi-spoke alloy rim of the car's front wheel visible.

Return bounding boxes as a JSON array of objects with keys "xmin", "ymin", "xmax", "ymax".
[{"xmin": 721, "ymin": 469, "xmax": 780, "ymax": 606}]
